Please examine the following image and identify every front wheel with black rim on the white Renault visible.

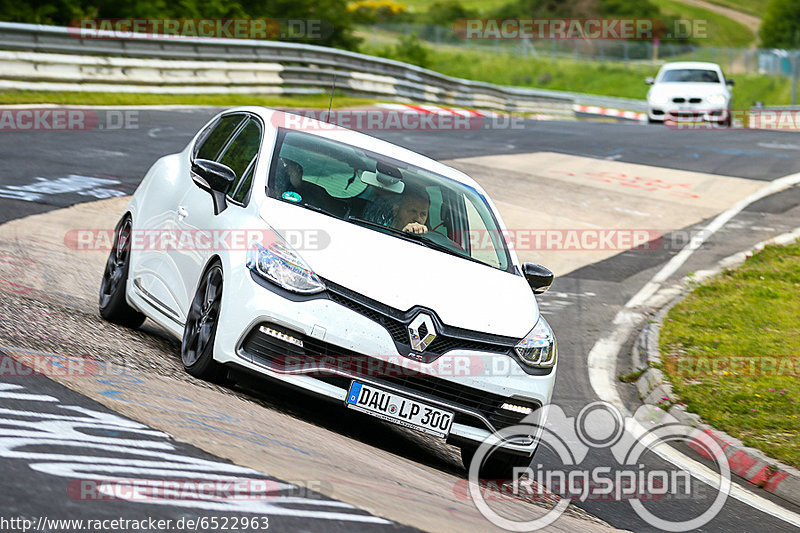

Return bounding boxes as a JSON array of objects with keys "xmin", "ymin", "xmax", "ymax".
[{"xmin": 181, "ymin": 261, "xmax": 225, "ymax": 382}]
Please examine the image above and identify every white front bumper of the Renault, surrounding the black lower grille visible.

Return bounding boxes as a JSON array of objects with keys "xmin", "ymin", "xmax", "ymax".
[{"xmin": 214, "ymin": 269, "xmax": 556, "ymax": 454}]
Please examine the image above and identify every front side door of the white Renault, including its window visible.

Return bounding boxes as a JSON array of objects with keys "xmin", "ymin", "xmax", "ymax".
[{"xmin": 169, "ymin": 115, "xmax": 264, "ymax": 318}]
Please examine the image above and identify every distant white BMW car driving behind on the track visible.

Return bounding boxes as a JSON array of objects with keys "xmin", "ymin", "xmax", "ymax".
[{"xmin": 645, "ymin": 61, "xmax": 733, "ymax": 126}]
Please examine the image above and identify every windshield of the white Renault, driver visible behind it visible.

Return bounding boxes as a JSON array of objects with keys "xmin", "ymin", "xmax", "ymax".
[{"xmin": 267, "ymin": 130, "xmax": 511, "ymax": 270}]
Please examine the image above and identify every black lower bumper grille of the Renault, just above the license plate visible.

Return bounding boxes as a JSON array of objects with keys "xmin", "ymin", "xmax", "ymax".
[{"xmin": 238, "ymin": 324, "xmax": 541, "ymax": 430}]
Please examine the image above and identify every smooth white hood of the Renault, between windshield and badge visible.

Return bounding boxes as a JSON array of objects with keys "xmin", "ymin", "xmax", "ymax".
[{"xmin": 261, "ymin": 200, "xmax": 539, "ymax": 338}]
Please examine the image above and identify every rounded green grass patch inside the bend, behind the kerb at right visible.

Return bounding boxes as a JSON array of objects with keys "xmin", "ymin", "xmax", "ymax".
[{"xmin": 660, "ymin": 243, "xmax": 800, "ymax": 467}]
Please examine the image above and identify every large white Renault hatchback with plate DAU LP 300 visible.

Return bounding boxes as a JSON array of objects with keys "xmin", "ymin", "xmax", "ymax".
[{"xmin": 100, "ymin": 107, "xmax": 557, "ymax": 476}]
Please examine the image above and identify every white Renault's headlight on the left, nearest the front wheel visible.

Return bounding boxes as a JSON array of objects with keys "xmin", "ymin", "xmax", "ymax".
[{"xmin": 247, "ymin": 234, "xmax": 325, "ymax": 294}]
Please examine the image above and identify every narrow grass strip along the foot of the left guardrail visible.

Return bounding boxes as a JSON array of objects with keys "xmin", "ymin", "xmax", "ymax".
[{"xmin": 0, "ymin": 91, "xmax": 377, "ymax": 108}]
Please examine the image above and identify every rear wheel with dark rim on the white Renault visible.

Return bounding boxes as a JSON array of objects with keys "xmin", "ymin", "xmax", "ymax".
[{"xmin": 98, "ymin": 216, "xmax": 146, "ymax": 329}]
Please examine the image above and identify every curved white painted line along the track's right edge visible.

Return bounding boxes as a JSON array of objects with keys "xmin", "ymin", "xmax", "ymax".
[{"xmin": 587, "ymin": 173, "xmax": 800, "ymax": 527}]
